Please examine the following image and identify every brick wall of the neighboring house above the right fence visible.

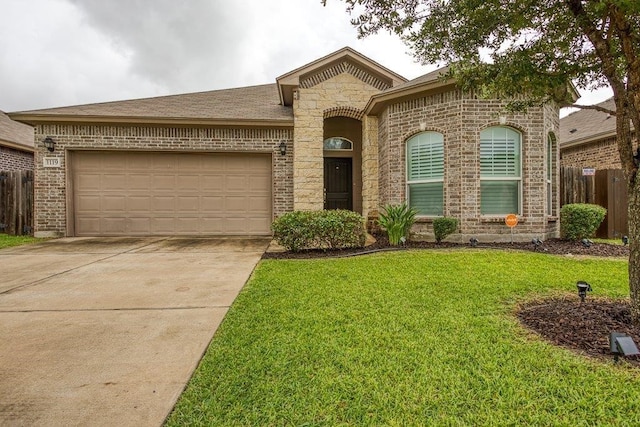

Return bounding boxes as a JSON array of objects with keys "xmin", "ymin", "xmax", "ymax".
[{"xmin": 560, "ymin": 136, "xmax": 622, "ymax": 169}]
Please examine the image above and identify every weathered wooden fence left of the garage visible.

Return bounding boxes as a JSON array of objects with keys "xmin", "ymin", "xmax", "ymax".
[{"xmin": 0, "ymin": 170, "xmax": 33, "ymax": 236}]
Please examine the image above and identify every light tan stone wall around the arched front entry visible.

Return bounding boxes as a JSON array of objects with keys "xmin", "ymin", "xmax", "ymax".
[{"xmin": 293, "ymin": 73, "xmax": 380, "ymax": 214}]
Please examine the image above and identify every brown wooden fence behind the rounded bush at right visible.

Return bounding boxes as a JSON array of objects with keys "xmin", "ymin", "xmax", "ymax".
[{"xmin": 560, "ymin": 167, "xmax": 629, "ymax": 239}]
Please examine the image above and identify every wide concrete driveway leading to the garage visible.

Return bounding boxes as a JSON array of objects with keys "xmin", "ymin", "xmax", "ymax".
[{"xmin": 0, "ymin": 237, "xmax": 269, "ymax": 426}]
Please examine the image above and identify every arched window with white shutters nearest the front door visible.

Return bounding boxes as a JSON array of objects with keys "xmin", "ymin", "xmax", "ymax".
[{"xmin": 407, "ymin": 132, "xmax": 444, "ymax": 216}]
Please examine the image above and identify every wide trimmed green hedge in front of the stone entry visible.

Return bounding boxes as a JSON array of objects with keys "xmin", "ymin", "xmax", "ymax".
[{"xmin": 271, "ymin": 210, "xmax": 366, "ymax": 252}]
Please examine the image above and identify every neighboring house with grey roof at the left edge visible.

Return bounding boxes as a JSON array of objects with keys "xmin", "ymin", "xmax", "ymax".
[{"xmin": 0, "ymin": 111, "xmax": 33, "ymax": 171}]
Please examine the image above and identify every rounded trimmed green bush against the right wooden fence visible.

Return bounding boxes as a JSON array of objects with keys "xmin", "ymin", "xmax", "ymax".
[{"xmin": 560, "ymin": 203, "xmax": 607, "ymax": 240}]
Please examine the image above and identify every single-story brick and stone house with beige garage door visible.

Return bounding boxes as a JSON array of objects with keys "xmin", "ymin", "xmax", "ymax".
[{"xmin": 11, "ymin": 48, "xmax": 559, "ymax": 241}]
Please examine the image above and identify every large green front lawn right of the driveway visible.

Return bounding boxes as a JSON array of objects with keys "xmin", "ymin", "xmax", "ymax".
[{"xmin": 167, "ymin": 250, "xmax": 640, "ymax": 426}]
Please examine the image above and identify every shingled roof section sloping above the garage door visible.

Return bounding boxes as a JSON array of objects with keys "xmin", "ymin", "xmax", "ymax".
[{"xmin": 9, "ymin": 84, "xmax": 293, "ymax": 127}]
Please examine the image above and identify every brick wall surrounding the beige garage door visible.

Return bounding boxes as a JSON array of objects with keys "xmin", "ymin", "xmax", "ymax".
[{"xmin": 34, "ymin": 125, "xmax": 293, "ymax": 237}]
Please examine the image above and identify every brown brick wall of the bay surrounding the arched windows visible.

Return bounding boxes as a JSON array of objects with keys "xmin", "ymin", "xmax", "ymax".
[{"xmin": 379, "ymin": 90, "xmax": 559, "ymax": 242}]
